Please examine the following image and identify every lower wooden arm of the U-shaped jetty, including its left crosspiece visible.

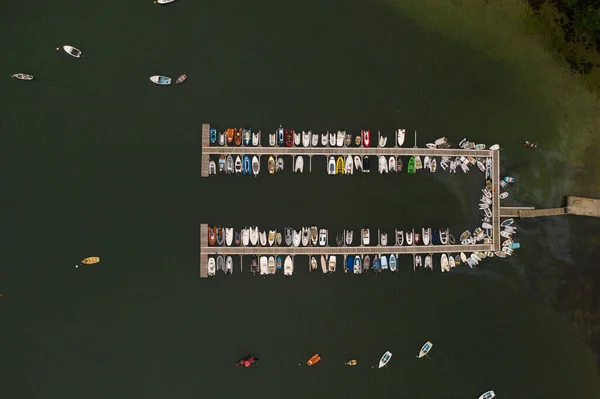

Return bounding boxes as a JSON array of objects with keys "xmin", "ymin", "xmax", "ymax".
[{"xmin": 200, "ymin": 224, "xmax": 494, "ymax": 278}]
